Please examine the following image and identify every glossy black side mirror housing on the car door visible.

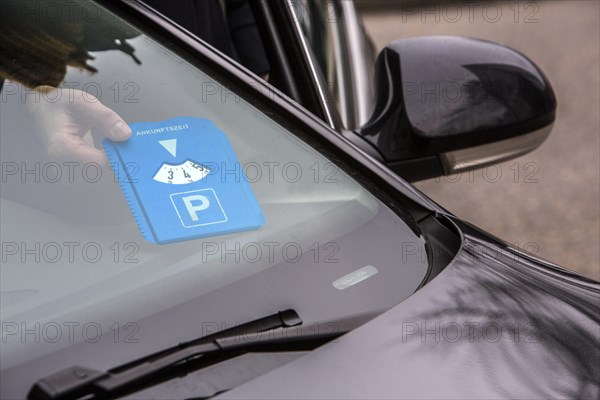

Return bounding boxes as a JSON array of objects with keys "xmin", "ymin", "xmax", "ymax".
[{"xmin": 357, "ymin": 36, "xmax": 556, "ymax": 181}]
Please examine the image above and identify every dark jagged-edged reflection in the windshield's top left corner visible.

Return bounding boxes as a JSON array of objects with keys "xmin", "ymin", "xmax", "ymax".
[{"xmin": 0, "ymin": 0, "xmax": 141, "ymax": 88}]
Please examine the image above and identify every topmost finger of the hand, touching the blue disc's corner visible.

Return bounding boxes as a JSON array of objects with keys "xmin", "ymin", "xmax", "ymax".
[{"xmin": 72, "ymin": 92, "xmax": 131, "ymax": 141}]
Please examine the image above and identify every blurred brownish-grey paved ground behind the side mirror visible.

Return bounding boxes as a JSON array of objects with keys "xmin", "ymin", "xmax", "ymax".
[{"xmin": 361, "ymin": 0, "xmax": 600, "ymax": 280}]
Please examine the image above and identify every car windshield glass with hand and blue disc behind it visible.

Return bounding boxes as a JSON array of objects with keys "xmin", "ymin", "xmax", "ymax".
[{"xmin": 0, "ymin": 0, "xmax": 428, "ymax": 398}]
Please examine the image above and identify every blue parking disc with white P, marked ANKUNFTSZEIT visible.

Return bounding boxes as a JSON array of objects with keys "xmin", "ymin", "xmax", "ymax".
[{"xmin": 102, "ymin": 117, "xmax": 265, "ymax": 244}]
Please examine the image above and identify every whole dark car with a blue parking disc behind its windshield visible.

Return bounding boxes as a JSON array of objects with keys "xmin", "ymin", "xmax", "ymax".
[{"xmin": 0, "ymin": 0, "xmax": 600, "ymax": 399}]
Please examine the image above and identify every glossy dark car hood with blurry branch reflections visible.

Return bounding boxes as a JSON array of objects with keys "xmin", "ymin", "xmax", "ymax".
[{"xmin": 219, "ymin": 220, "xmax": 600, "ymax": 399}]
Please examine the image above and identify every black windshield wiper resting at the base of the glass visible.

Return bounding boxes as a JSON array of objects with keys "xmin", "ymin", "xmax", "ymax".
[{"xmin": 27, "ymin": 310, "xmax": 345, "ymax": 400}]
